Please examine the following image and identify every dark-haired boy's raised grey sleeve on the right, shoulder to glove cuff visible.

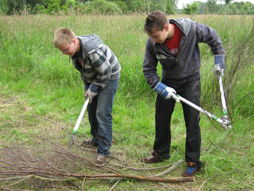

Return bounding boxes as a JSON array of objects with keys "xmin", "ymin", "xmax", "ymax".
[{"xmin": 195, "ymin": 23, "xmax": 225, "ymax": 55}]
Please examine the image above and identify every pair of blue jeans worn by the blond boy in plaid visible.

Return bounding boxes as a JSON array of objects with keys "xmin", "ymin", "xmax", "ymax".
[{"xmin": 88, "ymin": 80, "xmax": 119, "ymax": 155}]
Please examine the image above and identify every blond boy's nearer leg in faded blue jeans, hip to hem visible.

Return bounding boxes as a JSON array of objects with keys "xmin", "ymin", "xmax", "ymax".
[{"xmin": 96, "ymin": 80, "xmax": 119, "ymax": 155}]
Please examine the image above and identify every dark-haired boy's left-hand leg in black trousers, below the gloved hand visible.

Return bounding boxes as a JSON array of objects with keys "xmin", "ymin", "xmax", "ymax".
[{"xmin": 153, "ymin": 95, "xmax": 175, "ymax": 159}]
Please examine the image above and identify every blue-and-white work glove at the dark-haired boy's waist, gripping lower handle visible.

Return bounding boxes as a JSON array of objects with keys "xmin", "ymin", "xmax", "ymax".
[{"xmin": 153, "ymin": 82, "xmax": 180, "ymax": 102}]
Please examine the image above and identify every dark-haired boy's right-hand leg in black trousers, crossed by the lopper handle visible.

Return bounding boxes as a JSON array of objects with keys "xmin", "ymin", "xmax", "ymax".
[{"xmin": 180, "ymin": 80, "xmax": 201, "ymax": 164}]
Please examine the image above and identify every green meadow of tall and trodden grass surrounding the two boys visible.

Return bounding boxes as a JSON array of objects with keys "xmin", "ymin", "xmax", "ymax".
[{"xmin": 0, "ymin": 14, "xmax": 254, "ymax": 191}]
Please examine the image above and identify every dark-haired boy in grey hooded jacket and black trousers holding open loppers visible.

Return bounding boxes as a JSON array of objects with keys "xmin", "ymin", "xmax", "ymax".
[{"xmin": 142, "ymin": 11, "xmax": 224, "ymax": 176}]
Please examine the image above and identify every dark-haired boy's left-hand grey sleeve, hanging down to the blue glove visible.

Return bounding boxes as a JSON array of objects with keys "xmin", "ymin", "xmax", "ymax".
[{"xmin": 143, "ymin": 39, "xmax": 160, "ymax": 88}]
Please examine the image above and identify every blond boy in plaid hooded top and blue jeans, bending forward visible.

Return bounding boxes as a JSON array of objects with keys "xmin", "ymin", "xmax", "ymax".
[{"xmin": 53, "ymin": 28, "xmax": 121, "ymax": 163}]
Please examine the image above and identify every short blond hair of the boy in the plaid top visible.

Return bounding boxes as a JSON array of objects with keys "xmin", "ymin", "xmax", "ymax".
[{"xmin": 53, "ymin": 28, "xmax": 76, "ymax": 48}]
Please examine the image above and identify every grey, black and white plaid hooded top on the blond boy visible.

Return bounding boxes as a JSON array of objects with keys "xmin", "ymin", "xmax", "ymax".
[{"xmin": 72, "ymin": 35, "xmax": 121, "ymax": 94}]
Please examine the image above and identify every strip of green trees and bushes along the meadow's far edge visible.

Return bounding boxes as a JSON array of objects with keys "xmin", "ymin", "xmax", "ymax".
[{"xmin": 0, "ymin": 0, "xmax": 254, "ymax": 15}]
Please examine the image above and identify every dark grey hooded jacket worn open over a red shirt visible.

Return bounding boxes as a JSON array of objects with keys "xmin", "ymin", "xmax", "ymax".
[{"xmin": 143, "ymin": 18, "xmax": 224, "ymax": 88}]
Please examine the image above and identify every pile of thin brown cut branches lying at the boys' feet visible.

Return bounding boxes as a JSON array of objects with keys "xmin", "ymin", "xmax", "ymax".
[{"xmin": 0, "ymin": 139, "xmax": 195, "ymax": 190}]
